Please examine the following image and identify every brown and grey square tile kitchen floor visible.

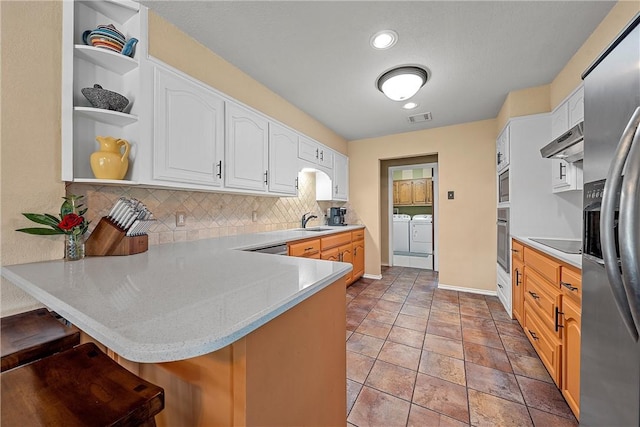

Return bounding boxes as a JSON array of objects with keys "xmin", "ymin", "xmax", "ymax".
[{"xmin": 347, "ymin": 267, "xmax": 577, "ymax": 427}]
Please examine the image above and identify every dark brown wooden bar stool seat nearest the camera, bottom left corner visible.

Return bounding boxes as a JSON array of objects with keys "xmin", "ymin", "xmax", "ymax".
[{"xmin": 0, "ymin": 343, "xmax": 164, "ymax": 427}]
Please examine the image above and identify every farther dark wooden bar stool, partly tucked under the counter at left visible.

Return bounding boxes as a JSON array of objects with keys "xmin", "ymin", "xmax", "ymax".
[{"xmin": 0, "ymin": 308, "xmax": 80, "ymax": 372}]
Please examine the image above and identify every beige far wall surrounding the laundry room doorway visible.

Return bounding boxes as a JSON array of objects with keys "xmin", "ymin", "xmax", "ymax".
[{"xmin": 349, "ymin": 120, "xmax": 496, "ymax": 290}]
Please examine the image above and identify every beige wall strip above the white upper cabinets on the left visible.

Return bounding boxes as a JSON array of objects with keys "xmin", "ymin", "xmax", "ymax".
[{"xmin": 149, "ymin": 11, "xmax": 347, "ymax": 154}]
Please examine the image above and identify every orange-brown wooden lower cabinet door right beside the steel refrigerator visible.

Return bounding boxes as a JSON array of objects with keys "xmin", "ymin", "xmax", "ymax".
[{"xmin": 560, "ymin": 290, "xmax": 581, "ymax": 419}]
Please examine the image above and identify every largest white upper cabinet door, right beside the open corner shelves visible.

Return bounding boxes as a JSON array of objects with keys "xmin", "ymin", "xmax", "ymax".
[{"xmin": 153, "ymin": 66, "xmax": 224, "ymax": 186}]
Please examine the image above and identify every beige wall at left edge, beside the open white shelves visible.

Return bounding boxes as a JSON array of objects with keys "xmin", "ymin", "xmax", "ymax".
[{"xmin": 0, "ymin": 1, "xmax": 65, "ymax": 316}]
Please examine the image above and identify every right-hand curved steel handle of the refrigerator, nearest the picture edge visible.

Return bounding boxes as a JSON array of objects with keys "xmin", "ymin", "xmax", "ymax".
[{"xmin": 619, "ymin": 107, "xmax": 640, "ymax": 342}]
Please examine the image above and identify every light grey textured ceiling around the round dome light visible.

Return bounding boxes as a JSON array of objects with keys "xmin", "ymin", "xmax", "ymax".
[{"xmin": 141, "ymin": 0, "xmax": 615, "ymax": 140}]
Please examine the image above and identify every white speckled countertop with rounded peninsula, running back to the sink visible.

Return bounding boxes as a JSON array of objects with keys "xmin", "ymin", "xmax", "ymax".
[{"xmin": 2, "ymin": 226, "xmax": 363, "ymax": 363}]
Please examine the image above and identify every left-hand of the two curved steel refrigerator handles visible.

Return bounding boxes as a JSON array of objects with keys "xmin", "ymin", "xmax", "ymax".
[{"xmin": 600, "ymin": 107, "xmax": 640, "ymax": 341}]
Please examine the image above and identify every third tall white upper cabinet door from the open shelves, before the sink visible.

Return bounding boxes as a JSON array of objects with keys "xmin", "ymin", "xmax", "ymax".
[{"xmin": 269, "ymin": 123, "xmax": 298, "ymax": 195}]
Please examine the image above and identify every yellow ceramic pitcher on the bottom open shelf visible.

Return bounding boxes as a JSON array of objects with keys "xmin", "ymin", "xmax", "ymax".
[{"xmin": 90, "ymin": 136, "xmax": 131, "ymax": 179}]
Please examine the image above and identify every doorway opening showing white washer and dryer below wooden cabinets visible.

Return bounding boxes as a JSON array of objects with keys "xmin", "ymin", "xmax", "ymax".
[{"xmin": 381, "ymin": 155, "xmax": 439, "ymax": 271}]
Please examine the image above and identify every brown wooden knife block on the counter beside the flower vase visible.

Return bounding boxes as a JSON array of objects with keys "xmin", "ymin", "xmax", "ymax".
[{"xmin": 85, "ymin": 217, "xmax": 149, "ymax": 256}]
